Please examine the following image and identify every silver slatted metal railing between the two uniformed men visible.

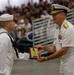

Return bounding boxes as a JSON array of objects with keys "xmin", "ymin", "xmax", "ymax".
[{"xmin": 33, "ymin": 18, "xmax": 56, "ymax": 46}]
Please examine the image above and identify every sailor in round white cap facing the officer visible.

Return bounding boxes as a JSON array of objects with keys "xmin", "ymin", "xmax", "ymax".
[{"xmin": 0, "ymin": 14, "xmax": 15, "ymax": 75}]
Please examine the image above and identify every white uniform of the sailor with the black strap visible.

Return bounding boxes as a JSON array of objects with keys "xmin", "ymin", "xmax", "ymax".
[{"xmin": 0, "ymin": 28, "xmax": 14, "ymax": 75}]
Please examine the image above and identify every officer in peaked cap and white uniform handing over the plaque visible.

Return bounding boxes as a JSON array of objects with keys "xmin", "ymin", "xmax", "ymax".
[{"xmin": 36, "ymin": 4, "xmax": 74, "ymax": 75}]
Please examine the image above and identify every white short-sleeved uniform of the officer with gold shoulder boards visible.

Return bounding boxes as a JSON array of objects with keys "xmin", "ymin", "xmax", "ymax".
[{"xmin": 53, "ymin": 20, "xmax": 74, "ymax": 75}]
